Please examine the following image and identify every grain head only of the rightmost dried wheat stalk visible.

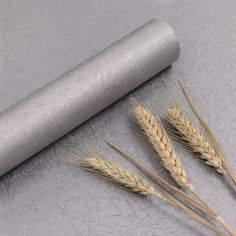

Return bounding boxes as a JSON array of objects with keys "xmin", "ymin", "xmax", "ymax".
[{"xmin": 166, "ymin": 106, "xmax": 225, "ymax": 174}]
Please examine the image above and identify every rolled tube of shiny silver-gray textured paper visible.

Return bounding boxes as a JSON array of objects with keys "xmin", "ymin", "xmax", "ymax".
[{"xmin": 0, "ymin": 19, "xmax": 179, "ymax": 175}]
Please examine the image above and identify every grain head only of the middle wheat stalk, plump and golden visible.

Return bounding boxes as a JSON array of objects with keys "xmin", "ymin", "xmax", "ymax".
[{"xmin": 133, "ymin": 104, "xmax": 193, "ymax": 191}]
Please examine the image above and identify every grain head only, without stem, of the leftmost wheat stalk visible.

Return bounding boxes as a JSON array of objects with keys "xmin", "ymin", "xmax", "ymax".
[{"xmin": 73, "ymin": 153, "xmax": 164, "ymax": 199}]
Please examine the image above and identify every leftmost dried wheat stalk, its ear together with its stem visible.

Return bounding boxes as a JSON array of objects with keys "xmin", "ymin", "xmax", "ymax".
[{"xmin": 69, "ymin": 153, "xmax": 222, "ymax": 235}]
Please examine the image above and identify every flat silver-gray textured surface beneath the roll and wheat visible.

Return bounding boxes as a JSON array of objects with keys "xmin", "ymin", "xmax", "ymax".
[{"xmin": 0, "ymin": 0, "xmax": 236, "ymax": 236}]
